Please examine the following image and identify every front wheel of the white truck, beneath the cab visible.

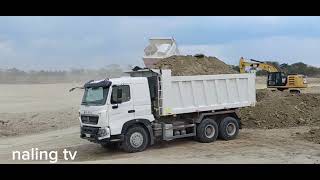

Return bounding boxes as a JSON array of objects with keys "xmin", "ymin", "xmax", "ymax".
[{"xmin": 121, "ymin": 126, "xmax": 149, "ymax": 153}]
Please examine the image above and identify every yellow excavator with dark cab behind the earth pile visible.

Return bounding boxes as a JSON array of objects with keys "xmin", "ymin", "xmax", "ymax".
[{"xmin": 239, "ymin": 57, "xmax": 307, "ymax": 93}]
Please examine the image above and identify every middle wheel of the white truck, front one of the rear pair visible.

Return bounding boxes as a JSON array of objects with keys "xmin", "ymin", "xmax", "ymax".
[{"xmin": 197, "ymin": 118, "xmax": 218, "ymax": 143}]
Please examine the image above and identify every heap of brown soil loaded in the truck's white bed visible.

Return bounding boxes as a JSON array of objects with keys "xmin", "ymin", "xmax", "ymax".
[{"xmin": 155, "ymin": 55, "xmax": 239, "ymax": 76}]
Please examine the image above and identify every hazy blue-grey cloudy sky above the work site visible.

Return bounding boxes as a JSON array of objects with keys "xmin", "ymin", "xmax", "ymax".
[{"xmin": 0, "ymin": 16, "xmax": 320, "ymax": 70}]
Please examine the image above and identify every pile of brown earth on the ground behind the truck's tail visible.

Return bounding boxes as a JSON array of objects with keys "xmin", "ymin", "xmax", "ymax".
[{"xmin": 240, "ymin": 89, "xmax": 320, "ymax": 129}]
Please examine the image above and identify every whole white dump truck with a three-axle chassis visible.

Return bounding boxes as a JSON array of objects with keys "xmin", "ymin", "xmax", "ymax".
[{"xmin": 79, "ymin": 69, "xmax": 256, "ymax": 152}]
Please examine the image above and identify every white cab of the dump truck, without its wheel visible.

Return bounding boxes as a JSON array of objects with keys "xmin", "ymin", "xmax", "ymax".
[{"xmin": 79, "ymin": 77, "xmax": 154, "ymax": 148}]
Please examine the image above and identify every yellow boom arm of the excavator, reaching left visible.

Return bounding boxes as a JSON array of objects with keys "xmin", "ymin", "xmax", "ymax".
[{"xmin": 239, "ymin": 57, "xmax": 280, "ymax": 73}]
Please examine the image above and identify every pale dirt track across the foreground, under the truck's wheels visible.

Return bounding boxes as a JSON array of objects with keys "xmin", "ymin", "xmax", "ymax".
[{"xmin": 0, "ymin": 127, "xmax": 320, "ymax": 164}]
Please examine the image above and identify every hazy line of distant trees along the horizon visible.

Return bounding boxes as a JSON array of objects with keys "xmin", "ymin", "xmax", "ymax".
[{"xmin": 0, "ymin": 61, "xmax": 320, "ymax": 84}]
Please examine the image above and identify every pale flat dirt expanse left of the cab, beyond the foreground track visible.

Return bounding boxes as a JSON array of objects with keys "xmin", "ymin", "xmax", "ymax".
[{"xmin": 0, "ymin": 84, "xmax": 82, "ymax": 137}]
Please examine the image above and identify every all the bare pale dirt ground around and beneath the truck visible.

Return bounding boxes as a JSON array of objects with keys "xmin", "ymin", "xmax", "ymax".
[{"xmin": 0, "ymin": 78, "xmax": 320, "ymax": 164}]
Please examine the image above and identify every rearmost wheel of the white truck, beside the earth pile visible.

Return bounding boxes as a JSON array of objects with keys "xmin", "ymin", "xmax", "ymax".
[{"xmin": 219, "ymin": 117, "xmax": 239, "ymax": 140}]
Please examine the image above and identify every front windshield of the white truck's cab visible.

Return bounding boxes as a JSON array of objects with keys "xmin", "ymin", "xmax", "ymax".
[{"xmin": 81, "ymin": 87, "xmax": 109, "ymax": 106}]
